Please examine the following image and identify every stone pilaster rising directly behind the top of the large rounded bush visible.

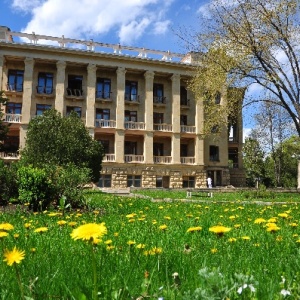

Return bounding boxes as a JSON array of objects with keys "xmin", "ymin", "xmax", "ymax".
[{"xmin": 55, "ymin": 60, "xmax": 67, "ymax": 115}]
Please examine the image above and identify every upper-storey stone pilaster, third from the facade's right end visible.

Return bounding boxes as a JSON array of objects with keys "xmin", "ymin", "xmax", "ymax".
[{"xmin": 144, "ymin": 71, "xmax": 154, "ymax": 130}]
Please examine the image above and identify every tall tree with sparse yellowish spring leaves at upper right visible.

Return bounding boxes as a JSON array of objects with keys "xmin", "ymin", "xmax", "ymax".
[{"xmin": 185, "ymin": 0, "xmax": 300, "ymax": 136}]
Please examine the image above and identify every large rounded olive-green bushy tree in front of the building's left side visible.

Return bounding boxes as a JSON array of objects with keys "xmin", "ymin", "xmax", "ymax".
[{"xmin": 21, "ymin": 109, "xmax": 103, "ymax": 182}]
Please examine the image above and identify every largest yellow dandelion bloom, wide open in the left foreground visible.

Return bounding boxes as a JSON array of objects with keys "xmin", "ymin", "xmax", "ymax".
[{"xmin": 71, "ymin": 223, "xmax": 107, "ymax": 241}]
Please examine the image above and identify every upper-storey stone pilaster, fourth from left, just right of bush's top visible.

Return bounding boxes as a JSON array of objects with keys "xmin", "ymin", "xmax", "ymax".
[{"xmin": 86, "ymin": 64, "xmax": 97, "ymax": 128}]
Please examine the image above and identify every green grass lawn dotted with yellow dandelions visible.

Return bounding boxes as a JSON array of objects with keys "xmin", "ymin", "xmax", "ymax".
[{"xmin": 0, "ymin": 192, "xmax": 300, "ymax": 300}]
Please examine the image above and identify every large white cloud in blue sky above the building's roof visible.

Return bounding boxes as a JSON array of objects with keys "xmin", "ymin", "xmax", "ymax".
[{"xmin": 13, "ymin": 0, "xmax": 174, "ymax": 44}]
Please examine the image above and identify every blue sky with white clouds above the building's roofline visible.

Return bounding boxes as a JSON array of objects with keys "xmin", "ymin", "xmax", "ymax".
[{"xmin": 0, "ymin": 0, "xmax": 209, "ymax": 53}]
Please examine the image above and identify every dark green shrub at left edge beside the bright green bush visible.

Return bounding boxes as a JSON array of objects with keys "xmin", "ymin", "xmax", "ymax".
[{"xmin": 0, "ymin": 160, "xmax": 18, "ymax": 204}]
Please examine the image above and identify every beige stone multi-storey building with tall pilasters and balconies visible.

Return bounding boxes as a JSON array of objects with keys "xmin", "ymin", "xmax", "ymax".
[{"xmin": 0, "ymin": 27, "xmax": 244, "ymax": 188}]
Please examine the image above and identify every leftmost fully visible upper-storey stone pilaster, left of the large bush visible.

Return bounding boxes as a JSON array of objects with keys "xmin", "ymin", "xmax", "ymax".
[{"xmin": 22, "ymin": 57, "xmax": 34, "ymax": 124}]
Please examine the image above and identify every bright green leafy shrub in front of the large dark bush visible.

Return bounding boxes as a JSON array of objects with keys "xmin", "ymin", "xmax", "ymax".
[{"xmin": 18, "ymin": 166, "xmax": 54, "ymax": 211}]
